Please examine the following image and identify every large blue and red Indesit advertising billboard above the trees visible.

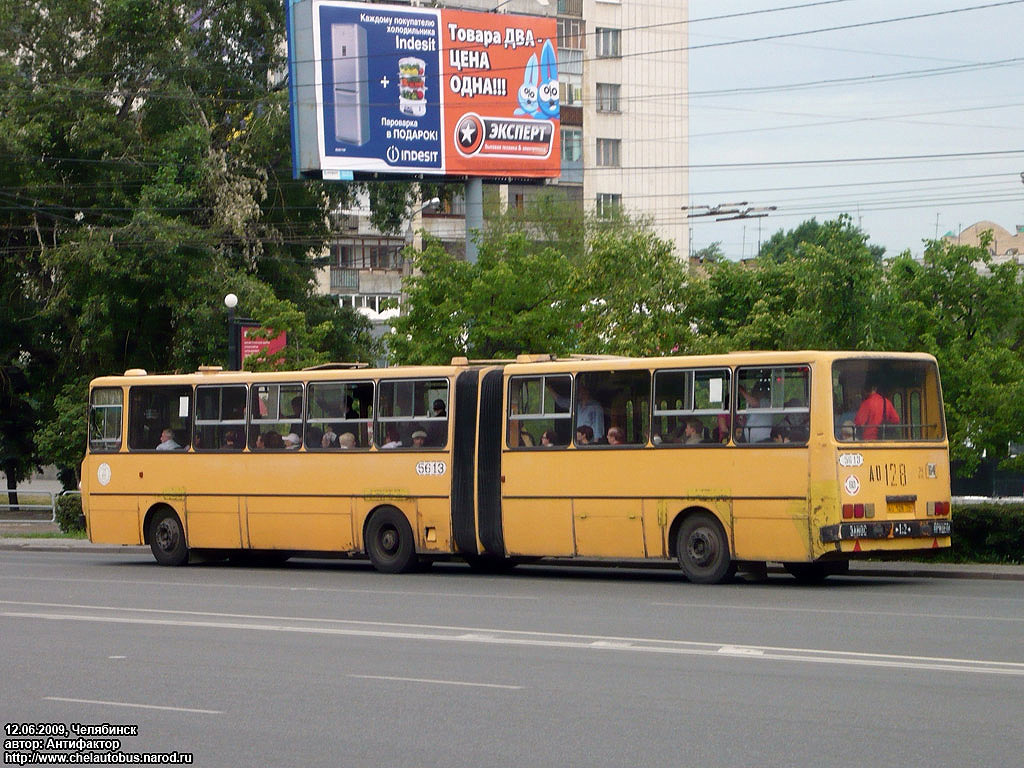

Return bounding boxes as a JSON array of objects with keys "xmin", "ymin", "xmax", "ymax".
[{"xmin": 288, "ymin": 0, "xmax": 560, "ymax": 179}]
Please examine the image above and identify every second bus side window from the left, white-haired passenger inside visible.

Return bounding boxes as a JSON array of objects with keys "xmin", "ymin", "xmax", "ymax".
[{"xmin": 128, "ymin": 385, "xmax": 193, "ymax": 451}]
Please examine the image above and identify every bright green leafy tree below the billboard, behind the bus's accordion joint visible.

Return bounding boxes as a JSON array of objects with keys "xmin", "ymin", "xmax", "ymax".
[{"xmin": 389, "ymin": 202, "xmax": 690, "ymax": 362}]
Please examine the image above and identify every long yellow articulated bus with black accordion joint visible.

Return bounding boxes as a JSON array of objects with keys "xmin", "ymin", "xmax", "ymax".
[{"xmin": 82, "ymin": 351, "xmax": 951, "ymax": 583}]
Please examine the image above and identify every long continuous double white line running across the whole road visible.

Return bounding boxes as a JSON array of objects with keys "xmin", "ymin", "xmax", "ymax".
[{"xmin": 8, "ymin": 601, "xmax": 1024, "ymax": 677}]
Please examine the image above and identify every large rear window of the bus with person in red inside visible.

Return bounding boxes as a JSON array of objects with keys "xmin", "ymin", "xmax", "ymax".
[{"xmin": 833, "ymin": 358, "xmax": 945, "ymax": 442}]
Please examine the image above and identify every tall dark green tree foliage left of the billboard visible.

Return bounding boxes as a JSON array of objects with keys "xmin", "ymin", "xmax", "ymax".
[{"xmin": 0, "ymin": 0, "xmax": 372, "ymax": 487}]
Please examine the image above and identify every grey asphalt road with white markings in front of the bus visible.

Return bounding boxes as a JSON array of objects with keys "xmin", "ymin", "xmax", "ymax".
[{"xmin": 0, "ymin": 551, "xmax": 1024, "ymax": 768}]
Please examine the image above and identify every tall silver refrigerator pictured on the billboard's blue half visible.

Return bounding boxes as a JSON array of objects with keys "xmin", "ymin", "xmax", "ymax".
[{"xmin": 331, "ymin": 24, "xmax": 370, "ymax": 144}]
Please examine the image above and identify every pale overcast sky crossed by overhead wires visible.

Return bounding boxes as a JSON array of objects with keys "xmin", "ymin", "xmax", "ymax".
[{"xmin": 684, "ymin": 0, "xmax": 1024, "ymax": 258}]
